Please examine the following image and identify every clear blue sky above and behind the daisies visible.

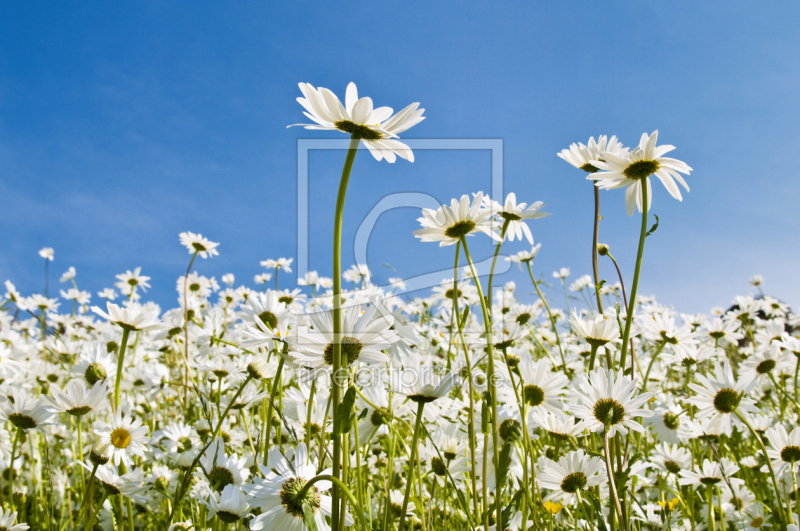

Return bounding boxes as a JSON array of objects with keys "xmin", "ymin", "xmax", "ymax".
[{"xmin": 0, "ymin": 1, "xmax": 800, "ymax": 312}]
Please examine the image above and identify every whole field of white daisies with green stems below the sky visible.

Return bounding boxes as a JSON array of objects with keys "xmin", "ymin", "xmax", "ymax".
[{"xmin": 0, "ymin": 83, "xmax": 800, "ymax": 531}]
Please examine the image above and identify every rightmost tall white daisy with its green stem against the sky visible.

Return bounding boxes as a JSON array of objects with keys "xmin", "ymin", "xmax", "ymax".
[{"xmin": 587, "ymin": 130, "xmax": 692, "ymax": 372}]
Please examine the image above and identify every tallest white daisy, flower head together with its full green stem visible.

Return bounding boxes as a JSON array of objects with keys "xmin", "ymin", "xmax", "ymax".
[{"xmin": 289, "ymin": 83, "xmax": 425, "ymax": 529}]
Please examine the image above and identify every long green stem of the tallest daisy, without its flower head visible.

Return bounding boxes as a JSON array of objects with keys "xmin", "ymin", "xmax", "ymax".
[{"xmin": 331, "ymin": 135, "xmax": 360, "ymax": 530}]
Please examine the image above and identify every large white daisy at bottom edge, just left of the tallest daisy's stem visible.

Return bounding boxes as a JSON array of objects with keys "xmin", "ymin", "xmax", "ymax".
[{"xmin": 244, "ymin": 443, "xmax": 353, "ymax": 531}]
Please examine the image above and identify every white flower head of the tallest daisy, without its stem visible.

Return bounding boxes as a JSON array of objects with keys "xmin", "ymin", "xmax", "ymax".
[{"xmin": 289, "ymin": 82, "xmax": 425, "ymax": 162}]
